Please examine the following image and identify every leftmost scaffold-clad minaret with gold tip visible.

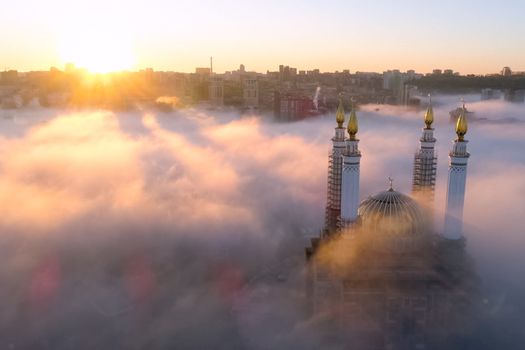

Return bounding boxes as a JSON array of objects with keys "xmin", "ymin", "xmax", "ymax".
[{"xmin": 325, "ymin": 100, "xmax": 346, "ymax": 233}]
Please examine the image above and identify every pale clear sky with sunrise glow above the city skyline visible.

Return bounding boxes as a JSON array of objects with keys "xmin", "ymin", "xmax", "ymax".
[{"xmin": 0, "ymin": 0, "xmax": 525, "ymax": 74}]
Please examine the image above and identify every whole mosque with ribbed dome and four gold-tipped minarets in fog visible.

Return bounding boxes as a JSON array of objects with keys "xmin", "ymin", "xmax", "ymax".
[{"xmin": 306, "ymin": 101, "xmax": 478, "ymax": 349}]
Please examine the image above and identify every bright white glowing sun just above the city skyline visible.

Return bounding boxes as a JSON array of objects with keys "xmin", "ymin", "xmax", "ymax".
[{"xmin": 59, "ymin": 26, "xmax": 135, "ymax": 73}]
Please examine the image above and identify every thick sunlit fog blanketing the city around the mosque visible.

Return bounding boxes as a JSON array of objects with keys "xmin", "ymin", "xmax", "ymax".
[{"xmin": 0, "ymin": 95, "xmax": 525, "ymax": 349}]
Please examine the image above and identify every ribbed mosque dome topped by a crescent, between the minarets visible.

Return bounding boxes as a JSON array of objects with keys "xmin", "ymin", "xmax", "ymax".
[{"xmin": 358, "ymin": 187, "xmax": 428, "ymax": 251}]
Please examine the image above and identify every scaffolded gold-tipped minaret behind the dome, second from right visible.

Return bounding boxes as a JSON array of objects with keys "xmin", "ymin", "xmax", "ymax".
[{"xmin": 412, "ymin": 95, "xmax": 437, "ymax": 202}]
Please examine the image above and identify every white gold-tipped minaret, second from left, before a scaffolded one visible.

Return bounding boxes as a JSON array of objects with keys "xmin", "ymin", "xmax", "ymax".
[{"xmin": 341, "ymin": 104, "xmax": 361, "ymax": 227}]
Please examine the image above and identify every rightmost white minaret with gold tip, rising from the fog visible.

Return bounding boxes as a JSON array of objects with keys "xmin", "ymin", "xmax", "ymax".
[{"xmin": 443, "ymin": 103, "xmax": 469, "ymax": 240}]
